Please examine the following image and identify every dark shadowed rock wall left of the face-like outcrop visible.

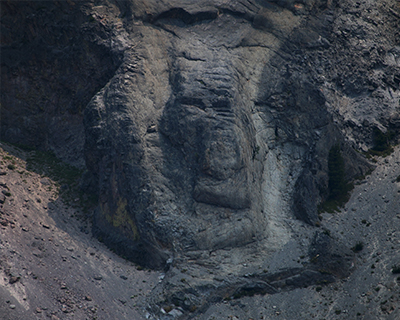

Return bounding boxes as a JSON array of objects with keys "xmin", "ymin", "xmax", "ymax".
[{"xmin": 0, "ymin": 1, "xmax": 121, "ymax": 168}]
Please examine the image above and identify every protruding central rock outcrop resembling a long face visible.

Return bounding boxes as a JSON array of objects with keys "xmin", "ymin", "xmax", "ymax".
[{"xmin": 85, "ymin": 1, "xmax": 376, "ymax": 267}]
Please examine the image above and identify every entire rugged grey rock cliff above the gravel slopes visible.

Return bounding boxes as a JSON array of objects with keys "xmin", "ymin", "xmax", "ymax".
[{"xmin": 1, "ymin": 0, "xmax": 400, "ymax": 318}]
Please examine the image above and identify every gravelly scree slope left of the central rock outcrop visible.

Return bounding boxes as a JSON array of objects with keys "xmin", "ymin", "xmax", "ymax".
[{"xmin": 0, "ymin": 144, "xmax": 160, "ymax": 320}]
